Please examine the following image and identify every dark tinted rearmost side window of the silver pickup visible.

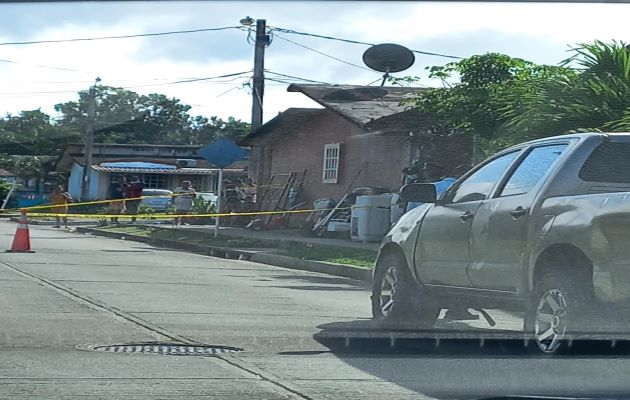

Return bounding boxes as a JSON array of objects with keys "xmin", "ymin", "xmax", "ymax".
[{"xmin": 579, "ymin": 143, "xmax": 630, "ymax": 183}]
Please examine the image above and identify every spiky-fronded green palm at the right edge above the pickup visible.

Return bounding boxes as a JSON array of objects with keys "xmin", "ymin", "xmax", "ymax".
[{"xmin": 503, "ymin": 41, "xmax": 630, "ymax": 136}]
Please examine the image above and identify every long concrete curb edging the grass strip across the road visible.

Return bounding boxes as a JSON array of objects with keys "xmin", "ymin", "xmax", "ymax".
[{"xmin": 76, "ymin": 227, "xmax": 372, "ymax": 282}]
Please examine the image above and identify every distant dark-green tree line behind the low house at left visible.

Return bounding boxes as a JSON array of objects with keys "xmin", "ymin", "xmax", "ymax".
[{"xmin": 0, "ymin": 86, "xmax": 249, "ymax": 178}]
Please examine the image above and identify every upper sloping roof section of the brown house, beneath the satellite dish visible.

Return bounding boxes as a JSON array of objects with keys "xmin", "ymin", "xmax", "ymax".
[{"xmin": 287, "ymin": 83, "xmax": 423, "ymax": 128}]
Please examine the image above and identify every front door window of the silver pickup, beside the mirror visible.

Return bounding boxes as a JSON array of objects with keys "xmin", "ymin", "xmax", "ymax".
[{"xmin": 449, "ymin": 151, "xmax": 520, "ymax": 203}]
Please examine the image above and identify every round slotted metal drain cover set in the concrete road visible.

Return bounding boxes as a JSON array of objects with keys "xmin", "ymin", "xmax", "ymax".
[{"xmin": 82, "ymin": 343, "xmax": 243, "ymax": 357}]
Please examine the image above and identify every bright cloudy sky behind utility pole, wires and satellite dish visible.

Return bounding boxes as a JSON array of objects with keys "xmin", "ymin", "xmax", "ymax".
[{"xmin": 0, "ymin": 1, "xmax": 630, "ymax": 125}]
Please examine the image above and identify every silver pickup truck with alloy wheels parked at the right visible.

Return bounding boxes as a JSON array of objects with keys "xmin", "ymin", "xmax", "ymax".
[{"xmin": 372, "ymin": 133, "xmax": 630, "ymax": 353}]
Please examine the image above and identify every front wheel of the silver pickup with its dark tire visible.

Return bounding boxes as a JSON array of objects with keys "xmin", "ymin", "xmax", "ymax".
[{"xmin": 372, "ymin": 252, "xmax": 440, "ymax": 329}]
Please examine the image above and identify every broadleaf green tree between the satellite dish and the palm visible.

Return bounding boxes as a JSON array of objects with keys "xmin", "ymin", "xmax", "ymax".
[{"xmin": 409, "ymin": 53, "xmax": 575, "ymax": 161}]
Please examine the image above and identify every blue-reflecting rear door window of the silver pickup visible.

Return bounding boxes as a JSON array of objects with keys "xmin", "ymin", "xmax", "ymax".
[{"xmin": 499, "ymin": 144, "xmax": 567, "ymax": 197}]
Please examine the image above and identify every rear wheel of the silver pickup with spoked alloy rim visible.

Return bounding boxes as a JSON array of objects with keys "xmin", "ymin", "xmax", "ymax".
[{"xmin": 524, "ymin": 272, "xmax": 594, "ymax": 355}]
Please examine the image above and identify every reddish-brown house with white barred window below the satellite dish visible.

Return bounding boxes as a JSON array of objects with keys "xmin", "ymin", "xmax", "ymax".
[{"xmin": 241, "ymin": 84, "xmax": 472, "ymax": 202}]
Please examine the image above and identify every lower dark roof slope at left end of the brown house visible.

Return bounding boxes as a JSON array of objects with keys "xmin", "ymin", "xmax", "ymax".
[{"xmin": 239, "ymin": 108, "xmax": 331, "ymax": 146}]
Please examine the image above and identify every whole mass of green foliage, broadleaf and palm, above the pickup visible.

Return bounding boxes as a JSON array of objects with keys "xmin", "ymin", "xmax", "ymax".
[{"xmin": 402, "ymin": 41, "xmax": 630, "ymax": 161}]
